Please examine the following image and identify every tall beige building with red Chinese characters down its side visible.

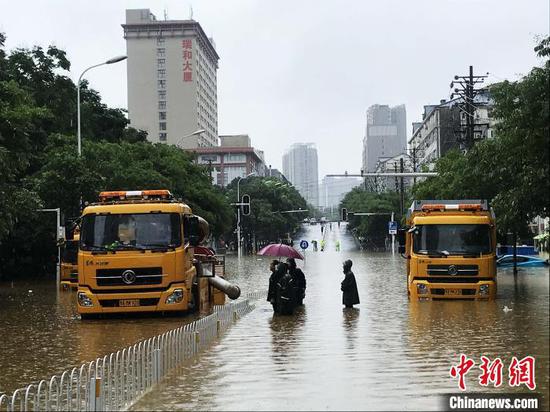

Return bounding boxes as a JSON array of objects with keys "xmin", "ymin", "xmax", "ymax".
[{"xmin": 122, "ymin": 9, "xmax": 219, "ymax": 148}]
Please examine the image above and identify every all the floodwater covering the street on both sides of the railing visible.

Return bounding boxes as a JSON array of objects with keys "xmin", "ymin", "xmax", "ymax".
[{"xmin": 0, "ymin": 223, "xmax": 549, "ymax": 410}]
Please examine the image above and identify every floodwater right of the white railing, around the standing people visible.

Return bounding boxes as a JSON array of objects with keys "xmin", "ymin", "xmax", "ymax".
[{"xmin": 135, "ymin": 224, "xmax": 549, "ymax": 410}]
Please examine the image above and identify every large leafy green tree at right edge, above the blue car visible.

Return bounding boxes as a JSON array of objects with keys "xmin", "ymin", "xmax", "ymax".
[{"xmin": 491, "ymin": 37, "xmax": 550, "ymax": 231}]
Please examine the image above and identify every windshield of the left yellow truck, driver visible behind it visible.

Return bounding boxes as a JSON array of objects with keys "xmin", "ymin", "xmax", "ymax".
[{"xmin": 80, "ymin": 213, "xmax": 181, "ymax": 250}]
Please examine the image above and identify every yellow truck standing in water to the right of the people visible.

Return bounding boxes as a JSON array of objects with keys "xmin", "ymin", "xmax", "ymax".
[{"xmin": 399, "ymin": 200, "xmax": 496, "ymax": 300}]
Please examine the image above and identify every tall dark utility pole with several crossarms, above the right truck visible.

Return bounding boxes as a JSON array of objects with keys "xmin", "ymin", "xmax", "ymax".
[{"xmin": 451, "ymin": 66, "xmax": 487, "ymax": 150}]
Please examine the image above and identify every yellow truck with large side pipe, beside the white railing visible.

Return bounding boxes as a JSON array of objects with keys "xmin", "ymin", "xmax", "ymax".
[{"xmin": 77, "ymin": 190, "xmax": 240, "ymax": 318}]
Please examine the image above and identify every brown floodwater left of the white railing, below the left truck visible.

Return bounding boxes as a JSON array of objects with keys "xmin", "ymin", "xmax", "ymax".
[{"xmin": 0, "ymin": 281, "xmax": 194, "ymax": 393}]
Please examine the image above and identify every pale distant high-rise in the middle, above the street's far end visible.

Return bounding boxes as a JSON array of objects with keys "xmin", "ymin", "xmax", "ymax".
[{"xmin": 283, "ymin": 143, "xmax": 319, "ymax": 207}]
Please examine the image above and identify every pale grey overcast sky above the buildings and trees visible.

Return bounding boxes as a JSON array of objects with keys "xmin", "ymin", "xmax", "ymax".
[{"xmin": 0, "ymin": 0, "xmax": 550, "ymax": 179}]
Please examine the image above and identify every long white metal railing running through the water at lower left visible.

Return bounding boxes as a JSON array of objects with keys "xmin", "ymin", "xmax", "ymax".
[{"xmin": 0, "ymin": 292, "xmax": 265, "ymax": 411}]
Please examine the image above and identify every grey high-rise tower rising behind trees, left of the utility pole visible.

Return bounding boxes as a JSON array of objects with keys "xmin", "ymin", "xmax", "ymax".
[{"xmin": 363, "ymin": 104, "xmax": 407, "ymax": 172}]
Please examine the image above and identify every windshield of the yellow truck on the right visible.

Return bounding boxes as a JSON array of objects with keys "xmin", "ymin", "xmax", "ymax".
[{"xmin": 413, "ymin": 225, "xmax": 491, "ymax": 256}]
